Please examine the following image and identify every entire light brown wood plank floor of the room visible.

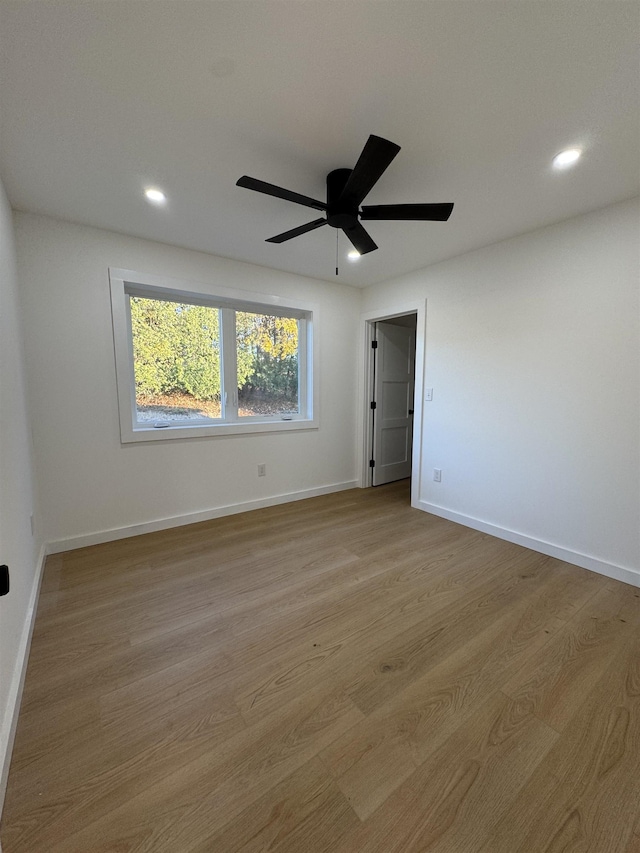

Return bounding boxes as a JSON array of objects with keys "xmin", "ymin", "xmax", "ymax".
[{"xmin": 1, "ymin": 483, "xmax": 640, "ymax": 853}]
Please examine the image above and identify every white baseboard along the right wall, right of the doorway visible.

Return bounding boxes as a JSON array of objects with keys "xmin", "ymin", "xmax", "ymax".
[{"xmin": 416, "ymin": 501, "xmax": 640, "ymax": 587}]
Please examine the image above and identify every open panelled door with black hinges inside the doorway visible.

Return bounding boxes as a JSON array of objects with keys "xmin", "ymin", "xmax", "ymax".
[{"xmin": 373, "ymin": 323, "xmax": 416, "ymax": 486}]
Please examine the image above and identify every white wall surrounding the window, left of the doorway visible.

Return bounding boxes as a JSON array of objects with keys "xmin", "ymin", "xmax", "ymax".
[{"xmin": 16, "ymin": 214, "xmax": 360, "ymax": 547}]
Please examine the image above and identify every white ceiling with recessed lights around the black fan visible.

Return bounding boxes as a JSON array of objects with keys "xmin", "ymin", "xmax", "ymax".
[{"xmin": 0, "ymin": 0, "xmax": 640, "ymax": 286}]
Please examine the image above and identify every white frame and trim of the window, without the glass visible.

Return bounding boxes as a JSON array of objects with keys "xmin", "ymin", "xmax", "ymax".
[{"xmin": 109, "ymin": 268, "xmax": 318, "ymax": 443}]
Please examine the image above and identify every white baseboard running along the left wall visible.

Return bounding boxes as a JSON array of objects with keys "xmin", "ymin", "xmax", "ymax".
[{"xmin": 0, "ymin": 545, "xmax": 46, "ymax": 816}]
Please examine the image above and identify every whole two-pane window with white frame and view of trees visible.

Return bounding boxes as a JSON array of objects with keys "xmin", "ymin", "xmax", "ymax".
[{"xmin": 110, "ymin": 270, "xmax": 317, "ymax": 442}]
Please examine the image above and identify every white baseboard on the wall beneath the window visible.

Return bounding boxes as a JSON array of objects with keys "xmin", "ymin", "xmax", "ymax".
[{"xmin": 47, "ymin": 480, "xmax": 358, "ymax": 554}]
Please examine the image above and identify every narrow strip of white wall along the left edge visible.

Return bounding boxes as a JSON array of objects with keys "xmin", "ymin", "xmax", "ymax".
[{"xmin": 0, "ymin": 183, "xmax": 41, "ymax": 811}]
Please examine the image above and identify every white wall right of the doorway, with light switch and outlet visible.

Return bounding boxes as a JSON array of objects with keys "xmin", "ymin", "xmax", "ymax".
[{"xmin": 362, "ymin": 201, "xmax": 640, "ymax": 582}]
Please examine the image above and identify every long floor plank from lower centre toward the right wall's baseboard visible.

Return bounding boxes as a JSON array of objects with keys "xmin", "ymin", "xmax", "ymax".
[{"xmin": 320, "ymin": 567, "xmax": 594, "ymax": 820}]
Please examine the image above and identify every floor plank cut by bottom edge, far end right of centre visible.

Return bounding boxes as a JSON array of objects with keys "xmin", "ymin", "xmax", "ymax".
[{"xmin": 332, "ymin": 692, "xmax": 559, "ymax": 853}]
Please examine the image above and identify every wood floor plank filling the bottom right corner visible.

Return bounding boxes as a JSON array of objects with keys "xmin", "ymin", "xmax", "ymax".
[{"xmin": 482, "ymin": 630, "xmax": 640, "ymax": 853}]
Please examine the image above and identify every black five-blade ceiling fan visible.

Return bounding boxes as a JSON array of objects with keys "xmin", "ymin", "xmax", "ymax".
[{"xmin": 236, "ymin": 135, "xmax": 453, "ymax": 255}]
